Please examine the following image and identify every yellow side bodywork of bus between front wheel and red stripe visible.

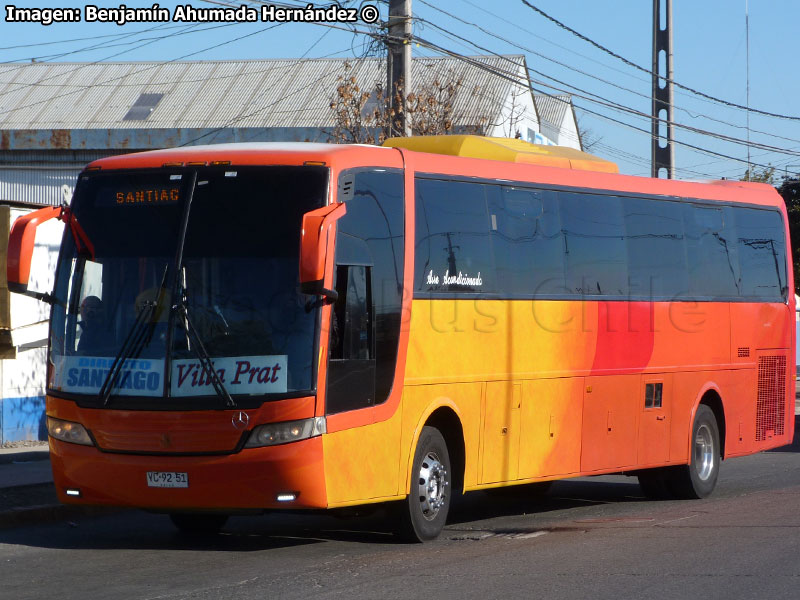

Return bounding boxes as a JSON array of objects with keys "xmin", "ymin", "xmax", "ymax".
[{"xmin": 402, "ymin": 300, "xmax": 597, "ymax": 489}]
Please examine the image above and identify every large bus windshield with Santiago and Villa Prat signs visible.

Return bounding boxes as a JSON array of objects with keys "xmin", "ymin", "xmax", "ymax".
[{"xmin": 48, "ymin": 167, "xmax": 328, "ymax": 407}]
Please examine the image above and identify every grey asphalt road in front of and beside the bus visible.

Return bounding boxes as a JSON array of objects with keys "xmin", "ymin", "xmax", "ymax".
[{"xmin": 0, "ymin": 428, "xmax": 800, "ymax": 600}]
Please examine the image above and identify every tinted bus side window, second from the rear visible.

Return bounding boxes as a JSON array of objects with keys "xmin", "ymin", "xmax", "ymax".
[{"xmin": 683, "ymin": 204, "xmax": 739, "ymax": 298}]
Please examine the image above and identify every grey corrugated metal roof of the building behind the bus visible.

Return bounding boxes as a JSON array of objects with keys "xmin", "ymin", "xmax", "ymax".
[{"xmin": 0, "ymin": 56, "xmax": 525, "ymax": 130}]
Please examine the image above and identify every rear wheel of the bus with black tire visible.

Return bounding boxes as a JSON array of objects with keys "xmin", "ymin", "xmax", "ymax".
[{"xmin": 668, "ymin": 404, "xmax": 722, "ymax": 499}]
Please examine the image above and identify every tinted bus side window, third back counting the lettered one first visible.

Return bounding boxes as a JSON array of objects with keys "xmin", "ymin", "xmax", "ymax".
[{"xmin": 558, "ymin": 192, "xmax": 628, "ymax": 296}]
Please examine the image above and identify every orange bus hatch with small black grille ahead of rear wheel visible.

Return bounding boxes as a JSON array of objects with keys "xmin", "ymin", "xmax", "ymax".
[{"xmin": 637, "ymin": 373, "xmax": 672, "ymax": 467}]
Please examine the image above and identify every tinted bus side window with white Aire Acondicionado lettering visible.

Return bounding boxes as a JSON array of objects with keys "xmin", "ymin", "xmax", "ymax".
[{"xmin": 414, "ymin": 179, "xmax": 495, "ymax": 293}]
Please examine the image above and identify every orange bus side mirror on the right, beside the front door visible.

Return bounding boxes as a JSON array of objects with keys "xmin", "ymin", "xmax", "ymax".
[{"xmin": 300, "ymin": 204, "xmax": 347, "ymax": 302}]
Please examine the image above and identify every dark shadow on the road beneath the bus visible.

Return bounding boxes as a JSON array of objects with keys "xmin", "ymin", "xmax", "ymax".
[{"xmin": 0, "ymin": 476, "xmax": 668, "ymax": 553}]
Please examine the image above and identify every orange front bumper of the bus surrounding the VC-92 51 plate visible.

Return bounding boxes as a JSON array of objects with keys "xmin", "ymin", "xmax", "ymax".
[{"xmin": 50, "ymin": 437, "xmax": 328, "ymax": 511}]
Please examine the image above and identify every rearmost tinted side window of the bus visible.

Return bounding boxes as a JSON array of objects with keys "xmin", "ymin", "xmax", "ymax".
[{"xmin": 734, "ymin": 208, "xmax": 786, "ymax": 302}]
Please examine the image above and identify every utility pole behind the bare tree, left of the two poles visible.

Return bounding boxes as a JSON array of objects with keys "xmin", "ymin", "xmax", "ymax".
[{"xmin": 386, "ymin": 0, "xmax": 411, "ymax": 136}]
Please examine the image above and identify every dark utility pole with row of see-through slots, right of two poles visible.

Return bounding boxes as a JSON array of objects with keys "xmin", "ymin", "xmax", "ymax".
[{"xmin": 650, "ymin": 0, "xmax": 675, "ymax": 179}]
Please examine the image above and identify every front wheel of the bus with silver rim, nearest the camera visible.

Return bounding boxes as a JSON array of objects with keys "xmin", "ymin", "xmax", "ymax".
[{"xmin": 399, "ymin": 427, "xmax": 452, "ymax": 542}]
